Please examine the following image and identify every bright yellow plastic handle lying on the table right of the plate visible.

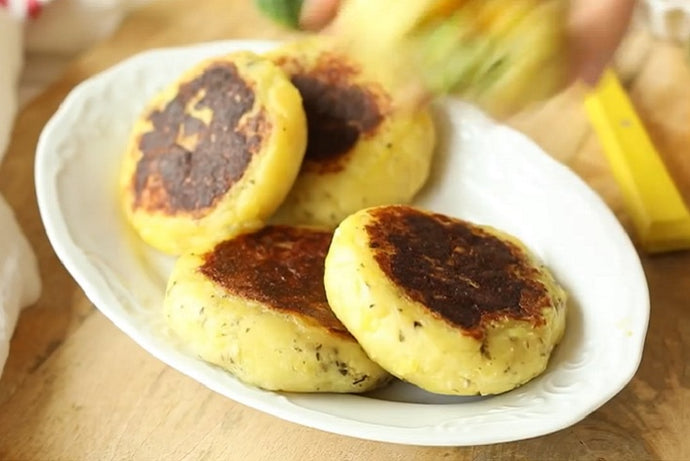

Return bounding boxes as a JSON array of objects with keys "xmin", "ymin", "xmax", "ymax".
[{"xmin": 585, "ymin": 70, "xmax": 690, "ymax": 252}]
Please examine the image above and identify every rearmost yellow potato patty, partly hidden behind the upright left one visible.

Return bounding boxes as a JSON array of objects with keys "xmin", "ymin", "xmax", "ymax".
[{"xmin": 267, "ymin": 39, "xmax": 435, "ymax": 228}]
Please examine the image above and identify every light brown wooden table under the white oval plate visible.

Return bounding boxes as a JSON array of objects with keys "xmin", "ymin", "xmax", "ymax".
[{"xmin": 0, "ymin": 0, "xmax": 690, "ymax": 460}]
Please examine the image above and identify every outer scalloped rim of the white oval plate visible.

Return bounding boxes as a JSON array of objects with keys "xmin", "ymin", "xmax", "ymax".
[{"xmin": 30, "ymin": 40, "xmax": 649, "ymax": 446}]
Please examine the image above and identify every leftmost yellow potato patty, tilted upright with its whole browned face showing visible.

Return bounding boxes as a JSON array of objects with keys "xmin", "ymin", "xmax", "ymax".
[{"xmin": 121, "ymin": 52, "xmax": 306, "ymax": 254}]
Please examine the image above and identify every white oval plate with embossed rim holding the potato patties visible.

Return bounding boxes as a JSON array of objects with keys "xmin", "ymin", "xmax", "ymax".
[{"xmin": 36, "ymin": 41, "xmax": 649, "ymax": 445}]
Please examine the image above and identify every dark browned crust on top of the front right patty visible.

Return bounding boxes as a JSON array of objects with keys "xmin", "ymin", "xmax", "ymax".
[{"xmin": 366, "ymin": 206, "xmax": 551, "ymax": 338}]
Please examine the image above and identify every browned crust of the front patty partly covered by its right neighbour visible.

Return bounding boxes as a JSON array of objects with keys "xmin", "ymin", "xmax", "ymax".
[{"xmin": 199, "ymin": 226, "xmax": 352, "ymax": 338}]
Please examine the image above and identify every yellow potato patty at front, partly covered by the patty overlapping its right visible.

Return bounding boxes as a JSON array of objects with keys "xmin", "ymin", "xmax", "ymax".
[{"xmin": 165, "ymin": 226, "xmax": 390, "ymax": 392}]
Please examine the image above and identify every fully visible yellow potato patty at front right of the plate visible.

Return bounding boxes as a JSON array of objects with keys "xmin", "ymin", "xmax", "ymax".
[{"xmin": 325, "ymin": 206, "xmax": 566, "ymax": 395}]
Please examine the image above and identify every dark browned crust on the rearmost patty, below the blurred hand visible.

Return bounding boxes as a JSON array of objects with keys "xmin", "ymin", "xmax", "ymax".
[{"xmin": 274, "ymin": 50, "xmax": 391, "ymax": 174}]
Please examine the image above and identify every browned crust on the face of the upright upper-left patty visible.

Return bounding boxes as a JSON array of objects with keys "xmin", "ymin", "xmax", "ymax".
[{"xmin": 132, "ymin": 61, "xmax": 270, "ymax": 217}]
